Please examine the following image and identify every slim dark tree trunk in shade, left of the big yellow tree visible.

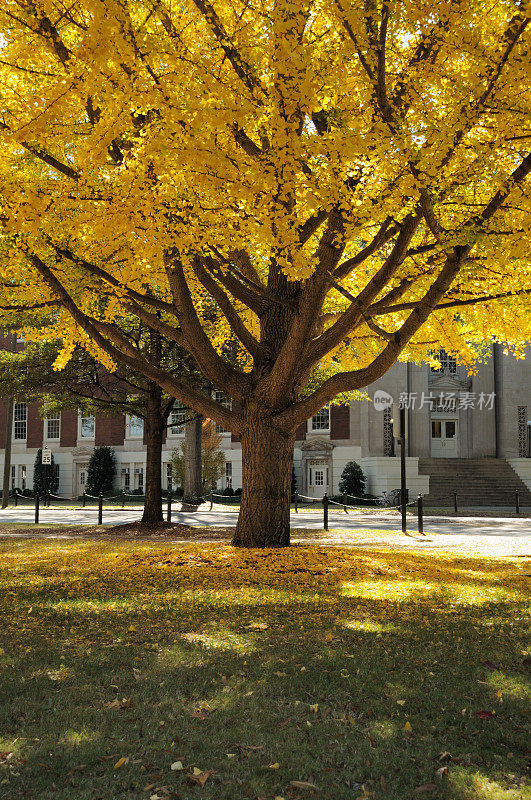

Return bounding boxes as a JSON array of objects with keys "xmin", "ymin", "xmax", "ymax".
[{"xmin": 141, "ymin": 385, "xmax": 166, "ymax": 525}]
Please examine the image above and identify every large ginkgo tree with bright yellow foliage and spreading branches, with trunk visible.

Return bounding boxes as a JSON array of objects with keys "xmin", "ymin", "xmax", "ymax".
[{"xmin": 0, "ymin": 0, "xmax": 531, "ymax": 546}]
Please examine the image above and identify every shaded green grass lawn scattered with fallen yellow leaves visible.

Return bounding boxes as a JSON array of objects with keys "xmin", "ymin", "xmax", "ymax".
[{"xmin": 0, "ymin": 540, "xmax": 530, "ymax": 800}]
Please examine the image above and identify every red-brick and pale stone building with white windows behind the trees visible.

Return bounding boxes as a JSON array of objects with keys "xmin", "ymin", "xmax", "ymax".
[{"xmin": 0, "ymin": 346, "xmax": 531, "ymax": 504}]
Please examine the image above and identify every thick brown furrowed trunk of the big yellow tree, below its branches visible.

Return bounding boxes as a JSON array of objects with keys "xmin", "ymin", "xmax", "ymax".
[{"xmin": 232, "ymin": 414, "xmax": 295, "ymax": 547}]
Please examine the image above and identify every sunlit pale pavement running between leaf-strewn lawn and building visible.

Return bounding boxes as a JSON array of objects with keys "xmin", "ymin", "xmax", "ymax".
[{"xmin": 0, "ymin": 504, "xmax": 531, "ymax": 556}]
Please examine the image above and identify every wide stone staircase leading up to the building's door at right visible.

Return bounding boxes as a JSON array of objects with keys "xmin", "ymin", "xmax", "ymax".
[{"xmin": 419, "ymin": 458, "xmax": 531, "ymax": 508}]
